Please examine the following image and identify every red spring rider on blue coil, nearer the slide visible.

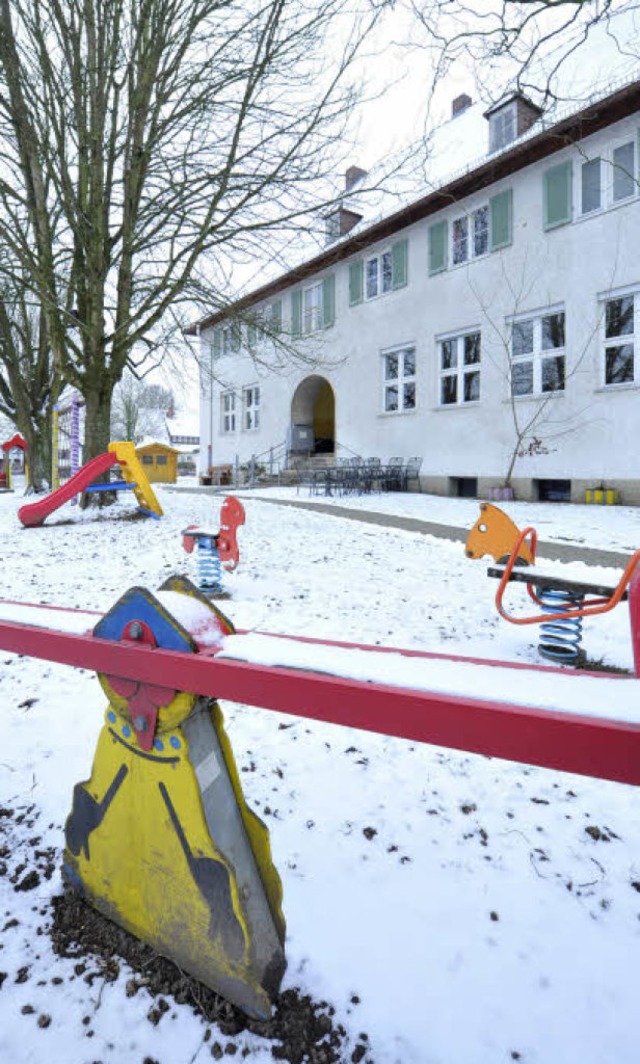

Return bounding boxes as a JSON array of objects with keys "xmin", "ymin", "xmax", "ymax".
[{"xmin": 182, "ymin": 495, "xmax": 245, "ymax": 599}]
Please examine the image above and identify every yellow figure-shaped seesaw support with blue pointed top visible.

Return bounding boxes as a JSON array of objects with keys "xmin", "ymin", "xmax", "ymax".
[{"xmin": 63, "ymin": 577, "xmax": 286, "ymax": 1018}]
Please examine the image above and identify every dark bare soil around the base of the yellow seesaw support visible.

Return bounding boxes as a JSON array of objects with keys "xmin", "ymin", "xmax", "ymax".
[{"xmin": 49, "ymin": 890, "xmax": 373, "ymax": 1064}]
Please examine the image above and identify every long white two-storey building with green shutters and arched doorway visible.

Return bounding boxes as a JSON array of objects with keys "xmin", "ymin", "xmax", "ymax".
[{"xmin": 189, "ymin": 81, "xmax": 640, "ymax": 503}]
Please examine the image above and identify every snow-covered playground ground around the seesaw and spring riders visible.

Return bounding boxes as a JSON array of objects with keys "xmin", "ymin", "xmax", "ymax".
[{"xmin": 0, "ymin": 486, "xmax": 640, "ymax": 1064}]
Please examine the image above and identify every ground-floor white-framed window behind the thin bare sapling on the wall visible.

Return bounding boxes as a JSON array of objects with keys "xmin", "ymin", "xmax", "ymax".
[{"xmin": 511, "ymin": 311, "xmax": 565, "ymax": 396}]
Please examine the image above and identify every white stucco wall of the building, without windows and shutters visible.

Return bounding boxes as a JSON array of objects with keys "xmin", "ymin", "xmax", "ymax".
[{"xmin": 196, "ymin": 105, "xmax": 640, "ymax": 495}]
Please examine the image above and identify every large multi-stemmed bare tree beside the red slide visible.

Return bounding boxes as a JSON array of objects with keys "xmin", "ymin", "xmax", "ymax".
[{"xmin": 0, "ymin": 0, "xmax": 384, "ymax": 459}]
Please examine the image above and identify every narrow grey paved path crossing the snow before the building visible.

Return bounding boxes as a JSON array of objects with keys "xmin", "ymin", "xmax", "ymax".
[{"xmin": 166, "ymin": 487, "xmax": 630, "ymax": 569}]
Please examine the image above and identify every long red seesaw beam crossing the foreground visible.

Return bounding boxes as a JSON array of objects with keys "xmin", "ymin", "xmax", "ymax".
[{"xmin": 0, "ymin": 612, "xmax": 640, "ymax": 785}]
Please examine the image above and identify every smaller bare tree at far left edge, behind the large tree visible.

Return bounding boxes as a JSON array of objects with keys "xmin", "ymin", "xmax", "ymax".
[{"xmin": 0, "ymin": 288, "xmax": 60, "ymax": 492}]
